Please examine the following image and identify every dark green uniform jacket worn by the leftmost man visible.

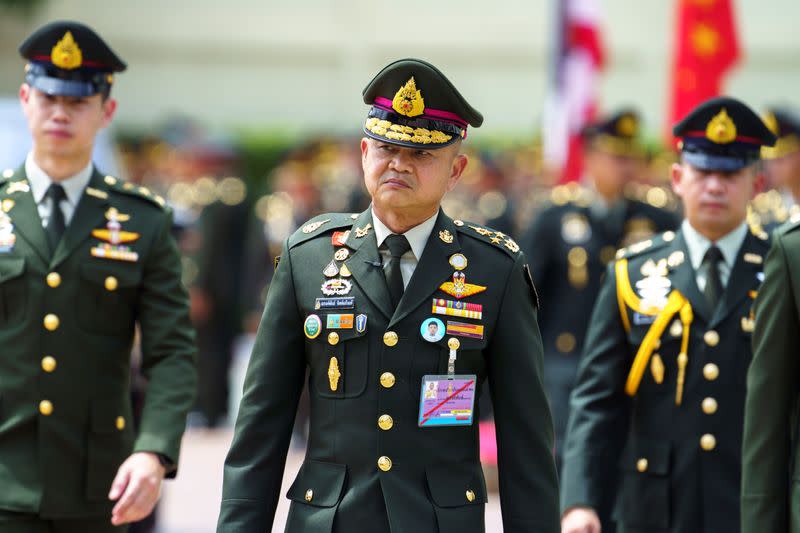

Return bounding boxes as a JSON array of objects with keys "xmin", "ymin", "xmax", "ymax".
[{"xmin": 0, "ymin": 170, "xmax": 195, "ymax": 518}]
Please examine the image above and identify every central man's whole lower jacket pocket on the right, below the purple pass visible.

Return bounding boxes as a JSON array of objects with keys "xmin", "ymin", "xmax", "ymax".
[{"xmin": 425, "ymin": 463, "xmax": 486, "ymax": 533}]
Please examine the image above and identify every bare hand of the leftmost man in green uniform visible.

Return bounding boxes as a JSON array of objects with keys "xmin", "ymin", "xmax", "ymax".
[{"xmin": 108, "ymin": 452, "xmax": 166, "ymax": 526}]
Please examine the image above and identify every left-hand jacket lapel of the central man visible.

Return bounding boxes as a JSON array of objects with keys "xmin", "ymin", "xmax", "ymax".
[{"xmin": 345, "ymin": 208, "xmax": 392, "ymax": 319}]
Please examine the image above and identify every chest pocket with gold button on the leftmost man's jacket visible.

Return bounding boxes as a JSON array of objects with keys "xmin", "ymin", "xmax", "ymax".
[{"xmin": 77, "ymin": 263, "xmax": 141, "ymax": 335}]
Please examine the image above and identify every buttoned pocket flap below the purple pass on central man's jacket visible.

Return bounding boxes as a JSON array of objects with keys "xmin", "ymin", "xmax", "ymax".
[{"xmin": 425, "ymin": 464, "xmax": 486, "ymax": 507}]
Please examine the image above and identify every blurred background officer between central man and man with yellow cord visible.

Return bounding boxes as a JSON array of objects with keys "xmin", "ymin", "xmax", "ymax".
[{"xmin": 520, "ymin": 109, "xmax": 678, "ymax": 470}]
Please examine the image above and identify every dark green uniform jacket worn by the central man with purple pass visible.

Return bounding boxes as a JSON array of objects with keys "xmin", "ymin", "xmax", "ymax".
[{"xmin": 217, "ymin": 210, "xmax": 559, "ymax": 533}]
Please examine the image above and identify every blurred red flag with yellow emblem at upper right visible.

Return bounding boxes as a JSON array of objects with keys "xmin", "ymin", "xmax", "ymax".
[{"xmin": 667, "ymin": 0, "xmax": 739, "ymax": 140}]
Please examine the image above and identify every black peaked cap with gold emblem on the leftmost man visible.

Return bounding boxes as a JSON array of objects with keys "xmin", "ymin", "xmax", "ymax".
[{"xmin": 19, "ymin": 20, "xmax": 126, "ymax": 97}]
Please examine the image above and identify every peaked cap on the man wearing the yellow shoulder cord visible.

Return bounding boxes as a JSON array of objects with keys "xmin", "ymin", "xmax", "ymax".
[{"xmin": 672, "ymin": 96, "xmax": 775, "ymax": 172}]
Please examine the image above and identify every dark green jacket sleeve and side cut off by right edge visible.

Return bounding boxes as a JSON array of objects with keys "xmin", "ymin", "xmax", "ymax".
[{"xmin": 742, "ymin": 217, "xmax": 800, "ymax": 533}]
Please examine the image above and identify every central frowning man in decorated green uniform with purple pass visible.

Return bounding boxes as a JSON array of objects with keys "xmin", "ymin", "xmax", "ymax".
[{"xmin": 217, "ymin": 59, "xmax": 559, "ymax": 533}]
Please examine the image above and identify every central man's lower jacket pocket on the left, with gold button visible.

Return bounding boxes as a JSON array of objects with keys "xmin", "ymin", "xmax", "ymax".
[{"xmin": 286, "ymin": 460, "xmax": 347, "ymax": 532}]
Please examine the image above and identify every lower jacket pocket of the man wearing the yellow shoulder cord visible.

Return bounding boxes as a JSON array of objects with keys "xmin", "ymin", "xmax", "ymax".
[{"xmin": 619, "ymin": 439, "xmax": 671, "ymax": 529}]
